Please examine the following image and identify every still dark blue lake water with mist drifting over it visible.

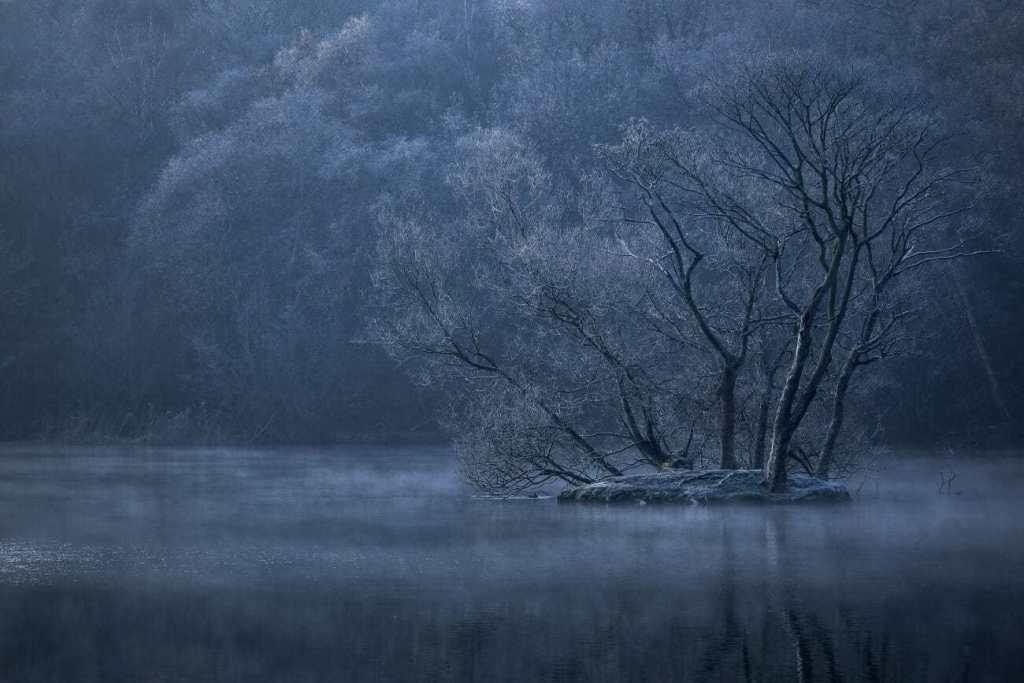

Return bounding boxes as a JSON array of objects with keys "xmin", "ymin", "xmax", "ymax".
[{"xmin": 0, "ymin": 449, "xmax": 1024, "ymax": 682}]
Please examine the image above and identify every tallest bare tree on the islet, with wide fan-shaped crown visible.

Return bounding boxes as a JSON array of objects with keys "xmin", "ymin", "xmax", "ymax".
[{"xmin": 694, "ymin": 63, "xmax": 978, "ymax": 490}]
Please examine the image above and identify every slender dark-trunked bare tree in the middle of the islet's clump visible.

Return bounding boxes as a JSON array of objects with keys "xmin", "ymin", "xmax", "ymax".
[{"xmin": 599, "ymin": 121, "xmax": 769, "ymax": 469}]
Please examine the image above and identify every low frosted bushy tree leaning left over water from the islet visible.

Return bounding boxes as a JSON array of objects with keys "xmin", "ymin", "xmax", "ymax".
[{"xmin": 377, "ymin": 130, "xmax": 700, "ymax": 493}]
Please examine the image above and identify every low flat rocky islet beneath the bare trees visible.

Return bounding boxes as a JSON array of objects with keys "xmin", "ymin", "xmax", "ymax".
[{"xmin": 558, "ymin": 470, "xmax": 850, "ymax": 505}]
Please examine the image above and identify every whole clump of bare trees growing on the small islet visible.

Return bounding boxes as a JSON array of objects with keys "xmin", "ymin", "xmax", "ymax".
[{"xmin": 378, "ymin": 58, "xmax": 991, "ymax": 493}]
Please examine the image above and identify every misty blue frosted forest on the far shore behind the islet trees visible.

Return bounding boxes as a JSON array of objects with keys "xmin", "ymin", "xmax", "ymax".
[{"xmin": 0, "ymin": 0, "xmax": 1024, "ymax": 446}]
